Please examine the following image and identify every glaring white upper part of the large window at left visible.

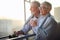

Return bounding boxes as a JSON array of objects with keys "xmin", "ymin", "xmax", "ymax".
[{"xmin": 0, "ymin": 0, "xmax": 24, "ymax": 20}]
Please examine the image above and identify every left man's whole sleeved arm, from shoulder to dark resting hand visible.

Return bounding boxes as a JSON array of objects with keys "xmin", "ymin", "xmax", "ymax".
[{"xmin": 16, "ymin": 15, "xmax": 33, "ymax": 35}]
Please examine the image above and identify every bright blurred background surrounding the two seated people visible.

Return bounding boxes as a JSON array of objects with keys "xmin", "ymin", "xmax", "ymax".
[{"xmin": 0, "ymin": 0, "xmax": 60, "ymax": 37}]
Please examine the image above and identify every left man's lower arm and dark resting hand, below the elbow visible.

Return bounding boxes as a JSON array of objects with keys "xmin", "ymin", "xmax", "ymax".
[{"xmin": 13, "ymin": 23, "xmax": 32, "ymax": 36}]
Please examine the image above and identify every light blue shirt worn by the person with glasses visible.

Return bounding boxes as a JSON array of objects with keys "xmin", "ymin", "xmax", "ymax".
[{"xmin": 36, "ymin": 13, "xmax": 57, "ymax": 40}]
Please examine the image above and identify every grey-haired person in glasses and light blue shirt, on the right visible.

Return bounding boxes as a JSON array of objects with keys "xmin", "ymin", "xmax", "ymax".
[{"xmin": 36, "ymin": 1, "xmax": 57, "ymax": 40}]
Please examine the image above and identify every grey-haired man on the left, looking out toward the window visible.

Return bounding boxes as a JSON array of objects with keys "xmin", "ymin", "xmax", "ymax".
[{"xmin": 15, "ymin": 1, "xmax": 40, "ymax": 35}]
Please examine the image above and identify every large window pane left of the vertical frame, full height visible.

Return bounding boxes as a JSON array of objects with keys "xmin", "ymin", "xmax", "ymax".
[{"xmin": 0, "ymin": 0, "xmax": 24, "ymax": 37}]
